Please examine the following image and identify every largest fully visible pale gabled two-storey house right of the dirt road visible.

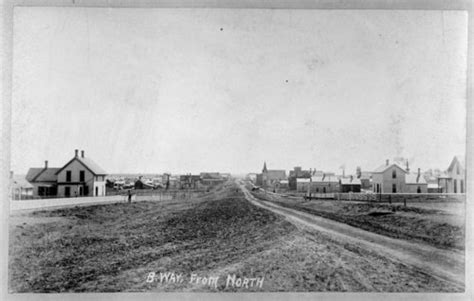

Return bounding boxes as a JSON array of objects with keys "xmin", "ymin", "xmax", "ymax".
[{"xmin": 372, "ymin": 160, "xmax": 407, "ymax": 193}]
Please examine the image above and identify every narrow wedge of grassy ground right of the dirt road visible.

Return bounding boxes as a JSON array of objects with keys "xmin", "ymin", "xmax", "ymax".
[{"xmin": 253, "ymin": 192, "xmax": 465, "ymax": 250}]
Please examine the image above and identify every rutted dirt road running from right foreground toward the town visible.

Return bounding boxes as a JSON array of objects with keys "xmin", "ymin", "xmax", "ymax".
[{"xmin": 239, "ymin": 182, "xmax": 464, "ymax": 287}]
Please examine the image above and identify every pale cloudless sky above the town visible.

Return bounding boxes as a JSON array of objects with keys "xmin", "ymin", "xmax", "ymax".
[{"xmin": 11, "ymin": 7, "xmax": 467, "ymax": 174}]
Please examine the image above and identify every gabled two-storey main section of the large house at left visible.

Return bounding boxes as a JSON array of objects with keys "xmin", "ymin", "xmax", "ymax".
[{"xmin": 56, "ymin": 149, "xmax": 107, "ymax": 197}]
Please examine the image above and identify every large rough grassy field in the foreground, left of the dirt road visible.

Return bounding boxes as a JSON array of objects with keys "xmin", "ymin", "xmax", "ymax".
[{"xmin": 9, "ymin": 180, "xmax": 462, "ymax": 292}]
